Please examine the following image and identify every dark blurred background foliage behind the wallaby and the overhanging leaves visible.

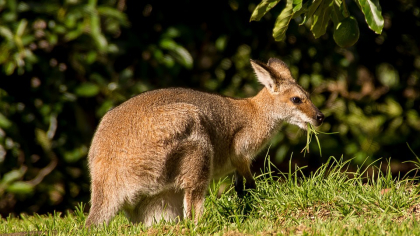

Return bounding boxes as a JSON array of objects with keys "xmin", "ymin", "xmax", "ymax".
[{"xmin": 0, "ymin": 0, "xmax": 420, "ymax": 216}]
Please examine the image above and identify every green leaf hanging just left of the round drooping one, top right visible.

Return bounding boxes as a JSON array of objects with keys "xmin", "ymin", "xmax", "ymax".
[{"xmin": 311, "ymin": 0, "xmax": 334, "ymax": 38}]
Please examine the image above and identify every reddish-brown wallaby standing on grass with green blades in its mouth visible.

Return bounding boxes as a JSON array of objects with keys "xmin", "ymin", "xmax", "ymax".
[{"xmin": 86, "ymin": 58, "xmax": 324, "ymax": 227}]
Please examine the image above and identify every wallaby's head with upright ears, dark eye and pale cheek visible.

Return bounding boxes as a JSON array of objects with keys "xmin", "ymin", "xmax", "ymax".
[{"xmin": 251, "ymin": 58, "xmax": 324, "ymax": 130}]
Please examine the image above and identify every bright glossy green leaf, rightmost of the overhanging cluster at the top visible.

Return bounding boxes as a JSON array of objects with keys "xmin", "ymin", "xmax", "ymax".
[{"xmin": 358, "ymin": 0, "xmax": 384, "ymax": 34}]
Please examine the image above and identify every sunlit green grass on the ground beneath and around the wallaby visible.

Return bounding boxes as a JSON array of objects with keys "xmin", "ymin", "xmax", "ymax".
[{"xmin": 0, "ymin": 158, "xmax": 420, "ymax": 235}]
